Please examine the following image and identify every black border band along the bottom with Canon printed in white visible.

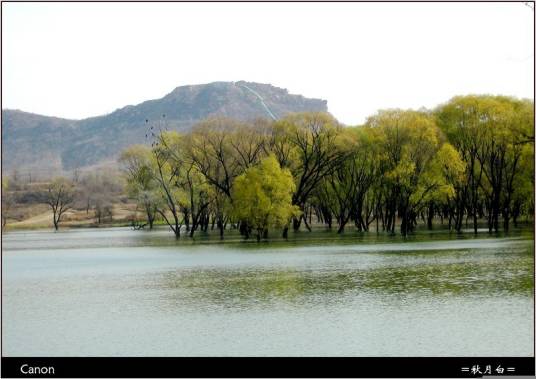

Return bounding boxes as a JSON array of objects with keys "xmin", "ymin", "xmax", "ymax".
[{"xmin": 2, "ymin": 357, "xmax": 535, "ymax": 378}]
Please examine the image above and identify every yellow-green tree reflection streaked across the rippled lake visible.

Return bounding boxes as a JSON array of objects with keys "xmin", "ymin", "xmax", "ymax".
[{"xmin": 161, "ymin": 252, "xmax": 534, "ymax": 307}]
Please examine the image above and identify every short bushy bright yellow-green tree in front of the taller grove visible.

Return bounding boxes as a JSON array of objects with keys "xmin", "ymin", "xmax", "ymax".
[{"xmin": 233, "ymin": 156, "xmax": 299, "ymax": 240}]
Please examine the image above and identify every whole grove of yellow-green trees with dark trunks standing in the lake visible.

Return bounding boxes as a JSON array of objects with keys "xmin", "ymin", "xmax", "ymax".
[{"xmin": 114, "ymin": 95, "xmax": 534, "ymax": 238}]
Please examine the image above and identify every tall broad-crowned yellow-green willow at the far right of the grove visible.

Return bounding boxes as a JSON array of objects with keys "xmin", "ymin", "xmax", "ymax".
[{"xmin": 437, "ymin": 95, "xmax": 534, "ymax": 233}]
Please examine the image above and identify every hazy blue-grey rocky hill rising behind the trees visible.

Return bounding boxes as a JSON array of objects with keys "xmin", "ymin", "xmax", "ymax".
[{"xmin": 2, "ymin": 82, "xmax": 327, "ymax": 176}]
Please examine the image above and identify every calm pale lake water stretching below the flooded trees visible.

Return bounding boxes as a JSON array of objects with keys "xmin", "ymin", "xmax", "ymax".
[{"xmin": 2, "ymin": 228, "xmax": 534, "ymax": 356}]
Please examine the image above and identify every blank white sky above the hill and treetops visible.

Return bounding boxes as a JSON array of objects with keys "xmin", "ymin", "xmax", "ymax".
[{"xmin": 2, "ymin": 2, "xmax": 534, "ymax": 124}]
